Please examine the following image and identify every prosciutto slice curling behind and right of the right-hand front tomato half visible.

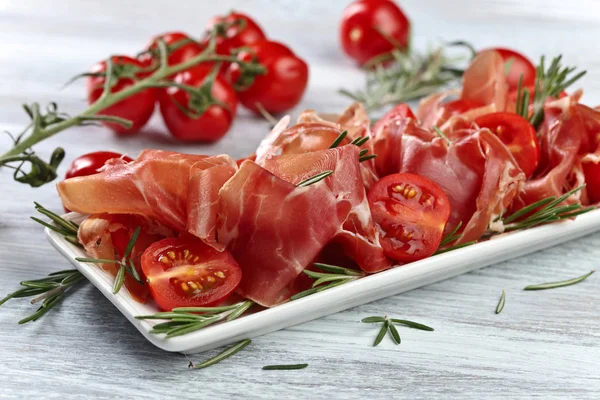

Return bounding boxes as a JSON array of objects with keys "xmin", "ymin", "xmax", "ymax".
[{"xmin": 375, "ymin": 118, "xmax": 525, "ymax": 244}]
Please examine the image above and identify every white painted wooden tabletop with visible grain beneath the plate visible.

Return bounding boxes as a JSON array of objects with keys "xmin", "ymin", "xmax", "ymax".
[{"xmin": 0, "ymin": 0, "xmax": 600, "ymax": 399}]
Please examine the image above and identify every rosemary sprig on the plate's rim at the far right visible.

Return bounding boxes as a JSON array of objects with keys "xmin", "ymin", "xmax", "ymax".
[{"xmin": 502, "ymin": 185, "xmax": 596, "ymax": 232}]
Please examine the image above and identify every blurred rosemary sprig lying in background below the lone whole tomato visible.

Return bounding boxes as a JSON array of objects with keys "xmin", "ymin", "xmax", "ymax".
[{"xmin": 339, "ymin": 42, "xmax": 472, "ymax": 111}]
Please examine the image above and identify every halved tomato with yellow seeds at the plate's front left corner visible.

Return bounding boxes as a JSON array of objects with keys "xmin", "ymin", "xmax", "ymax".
[{"xmin": 142, "ymin": 238, "xmax": 242, "ymax": 311}]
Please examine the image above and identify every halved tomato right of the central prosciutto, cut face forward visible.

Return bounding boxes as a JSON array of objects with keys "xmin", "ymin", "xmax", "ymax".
[{"xmin": 367, "ymin": 173, "xmax": 450, "ymax": 262}]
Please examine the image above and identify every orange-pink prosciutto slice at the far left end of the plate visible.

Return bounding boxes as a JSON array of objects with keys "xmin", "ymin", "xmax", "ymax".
[{"xmin": 57, "ymin": 150, "xmax": 237, "ymax": 247}]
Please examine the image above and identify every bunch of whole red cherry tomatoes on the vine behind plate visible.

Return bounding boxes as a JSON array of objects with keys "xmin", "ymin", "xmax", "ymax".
[{"xmin": 87, "ymin": 12, "xmax": 308, "ymax": 142}]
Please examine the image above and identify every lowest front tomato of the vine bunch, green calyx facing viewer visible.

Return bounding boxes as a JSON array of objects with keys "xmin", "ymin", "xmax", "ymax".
[{"xmin": 159, "ymin": 65, "xmax": 237, "ymax": 142}]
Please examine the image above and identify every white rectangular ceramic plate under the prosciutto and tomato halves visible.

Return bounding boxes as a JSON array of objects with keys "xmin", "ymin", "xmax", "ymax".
[{"xmin": 46, "ymin": 210, "xmax": 600, "ymax": 353}]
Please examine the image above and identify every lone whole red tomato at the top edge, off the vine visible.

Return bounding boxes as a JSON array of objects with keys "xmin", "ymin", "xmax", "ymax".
[{"xmin": 340, "ymin": 0, "xmax": 410, "ymax": 65}]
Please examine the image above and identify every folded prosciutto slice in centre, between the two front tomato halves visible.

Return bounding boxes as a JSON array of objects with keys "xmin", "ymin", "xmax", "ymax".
[{"xmin": 218, "ymin": 146, "xmax": 365, "ymax": 307}]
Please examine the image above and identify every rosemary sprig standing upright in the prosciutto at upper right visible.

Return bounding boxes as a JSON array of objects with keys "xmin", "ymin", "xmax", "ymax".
[{"xmin": 516, "ymin": 55, "xmax": 586, "ymax": 127}]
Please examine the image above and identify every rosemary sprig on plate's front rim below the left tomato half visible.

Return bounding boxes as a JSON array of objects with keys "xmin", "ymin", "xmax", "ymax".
[{"xmin": 135, "ymin": 301, "xmax": 254, "ymax": 338}]
